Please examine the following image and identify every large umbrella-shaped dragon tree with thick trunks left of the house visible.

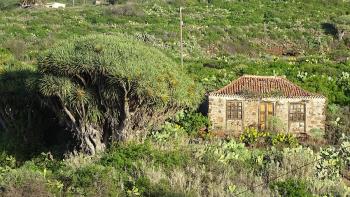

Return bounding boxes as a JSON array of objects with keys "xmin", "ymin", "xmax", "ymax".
[{"xmin": 38, "ymin": 35, "xmax": 201, "ymax": 154}]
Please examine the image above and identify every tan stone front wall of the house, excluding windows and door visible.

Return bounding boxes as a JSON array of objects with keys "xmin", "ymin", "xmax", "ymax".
[{"xmin": 208, "ymin": 95, "xmax": 326, "ymax": 134}]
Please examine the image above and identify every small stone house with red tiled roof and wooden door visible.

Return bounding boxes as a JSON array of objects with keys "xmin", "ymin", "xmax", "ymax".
[{"xmin": 208, "ymin": 75, "xmax": 326, "ymax": 135}]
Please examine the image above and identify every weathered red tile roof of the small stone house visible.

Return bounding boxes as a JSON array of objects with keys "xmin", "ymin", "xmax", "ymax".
[{"xmin": 212, "ymin": 75, "xmax": 321, "ymax": 97}]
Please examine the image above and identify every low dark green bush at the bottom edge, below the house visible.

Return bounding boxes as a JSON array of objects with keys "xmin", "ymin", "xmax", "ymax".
[{"xmin": 270, "ymin": 179, "xmax": 313, "ymax": 197}]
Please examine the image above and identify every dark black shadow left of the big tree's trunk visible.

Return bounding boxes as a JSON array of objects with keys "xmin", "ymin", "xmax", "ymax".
[{"xmin": 0, "ymin": 68, "xmax": 73, "ymax": 161}]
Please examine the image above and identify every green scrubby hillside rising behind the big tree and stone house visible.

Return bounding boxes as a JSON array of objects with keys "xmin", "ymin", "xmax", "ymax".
[{"xmin": 0, "ymin": 0, "xmax": 350, "ymax": 104}]
